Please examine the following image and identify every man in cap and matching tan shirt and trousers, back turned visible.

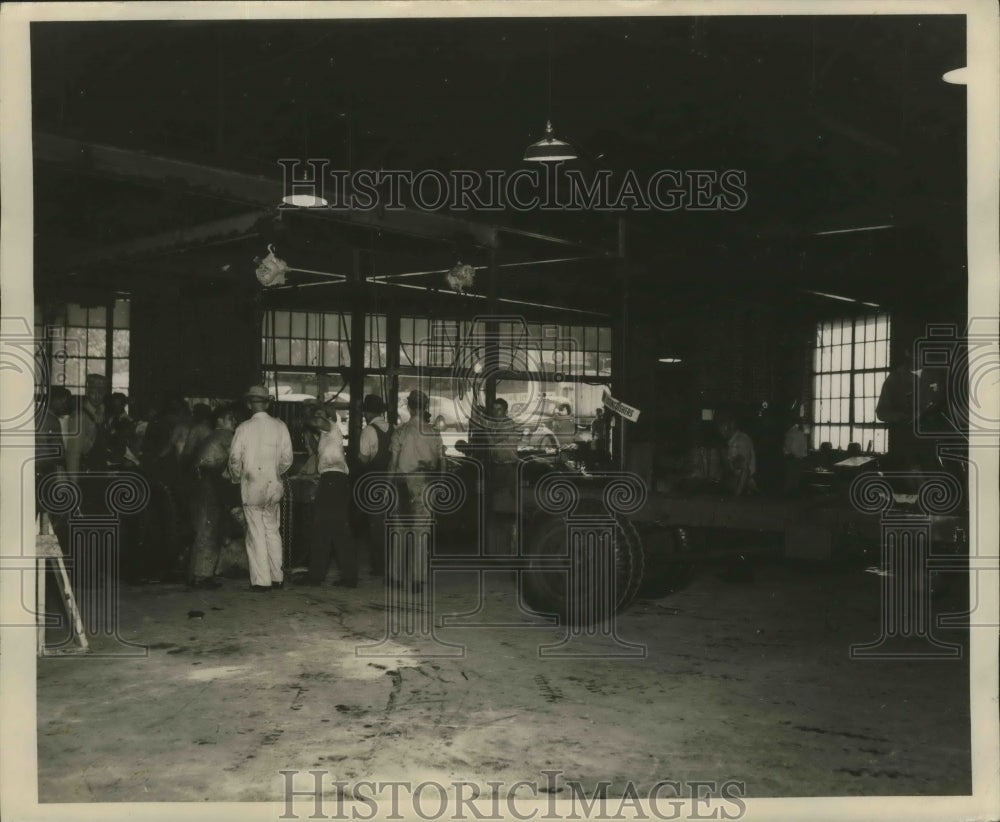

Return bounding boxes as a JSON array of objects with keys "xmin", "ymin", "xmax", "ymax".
[{"xmin": 389, "ymin": 391, "xmax": 448, "ymax": 590}]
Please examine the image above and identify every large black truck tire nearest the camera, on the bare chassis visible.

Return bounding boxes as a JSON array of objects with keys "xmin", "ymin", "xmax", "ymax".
[{"xmin": 521, "ymin": 517, "xmax": 644, "ymax": 625}]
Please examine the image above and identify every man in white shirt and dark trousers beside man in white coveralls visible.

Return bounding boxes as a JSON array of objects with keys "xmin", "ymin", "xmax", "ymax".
[{"xmin": 305, "ymin": 405, "xmax": 358, "ymax": 588}]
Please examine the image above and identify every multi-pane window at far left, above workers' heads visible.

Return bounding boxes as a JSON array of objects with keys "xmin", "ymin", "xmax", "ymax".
[{"xmin": 39, "ymin": 298, "xmax": 130, "ymax": 394}]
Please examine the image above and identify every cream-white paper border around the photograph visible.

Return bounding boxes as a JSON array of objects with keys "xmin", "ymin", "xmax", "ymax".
[{"xmin": 0, "ymin": 0, "xmax": 1000, "ymax": 822}]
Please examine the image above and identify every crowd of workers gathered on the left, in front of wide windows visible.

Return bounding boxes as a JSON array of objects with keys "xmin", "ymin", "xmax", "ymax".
[{"xmin": 36, "ymin": 375, "xmax": 500, "ymax": 592}]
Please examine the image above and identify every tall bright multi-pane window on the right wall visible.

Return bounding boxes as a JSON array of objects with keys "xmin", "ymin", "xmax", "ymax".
[{"xmin": 813, "ymin": 314, "xmax": 890, "ymax": 453}]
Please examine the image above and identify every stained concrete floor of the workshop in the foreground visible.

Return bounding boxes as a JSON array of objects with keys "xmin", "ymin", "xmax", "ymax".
[{"xmin": 38, "ymin": 565, "xmax": 971, "ymax": 804}]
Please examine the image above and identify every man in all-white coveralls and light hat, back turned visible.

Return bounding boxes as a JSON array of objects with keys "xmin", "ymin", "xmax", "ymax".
[{"xmin": 229, "ymin": 385, "xmax": 292, "ymax": 592}]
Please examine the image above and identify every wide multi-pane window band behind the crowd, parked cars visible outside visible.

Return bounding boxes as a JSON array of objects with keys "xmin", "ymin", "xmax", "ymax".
[{"xmin": 261, "ymin": 310, "xmax": 612, "ymax": 448}]
